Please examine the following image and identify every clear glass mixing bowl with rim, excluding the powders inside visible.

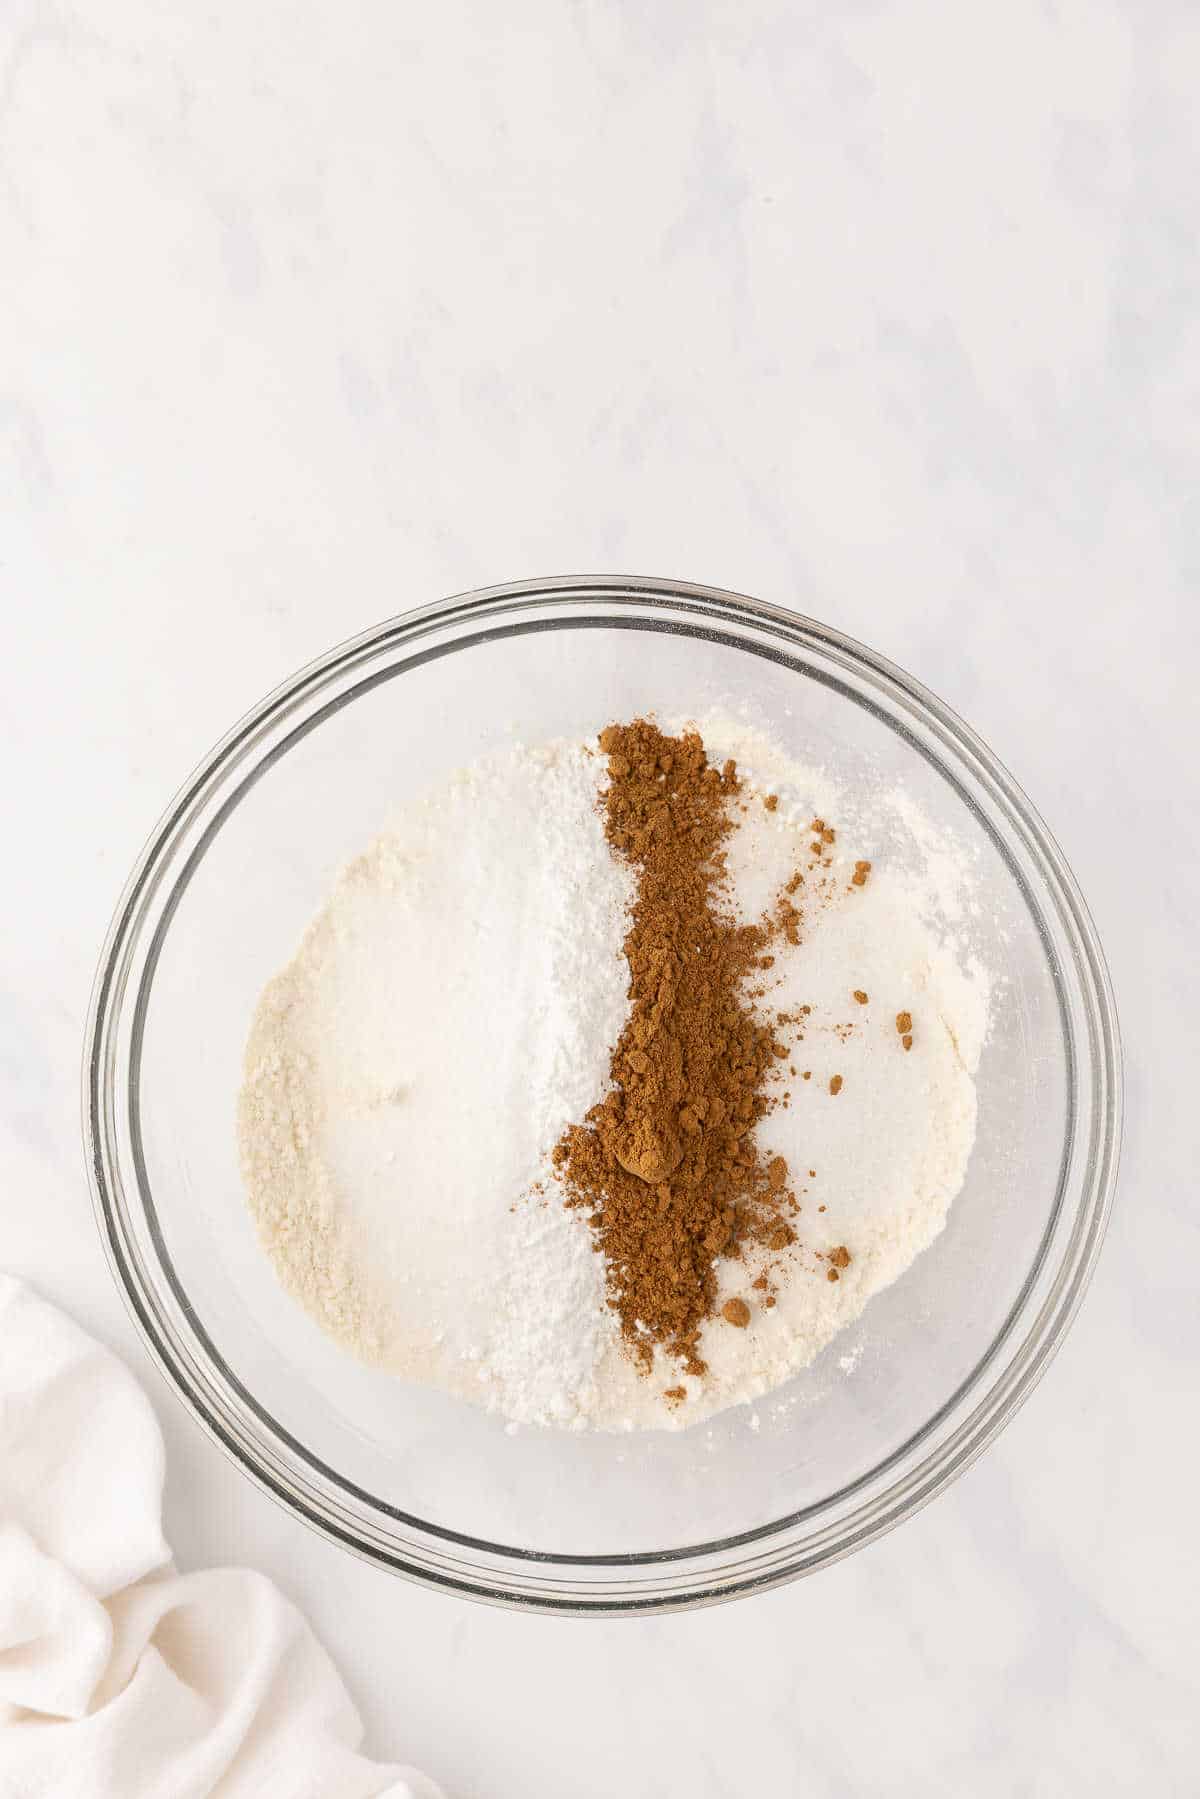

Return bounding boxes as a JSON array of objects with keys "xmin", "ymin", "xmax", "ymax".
[{"xmin": 85, "ymin": 577, "xmax": 1121, "ymax": 1614}]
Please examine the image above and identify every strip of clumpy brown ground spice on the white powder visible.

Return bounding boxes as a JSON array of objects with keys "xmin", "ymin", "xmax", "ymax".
[{"xmin": 554, "ymin": 720, "xmax": 799, "ymax": 1374}]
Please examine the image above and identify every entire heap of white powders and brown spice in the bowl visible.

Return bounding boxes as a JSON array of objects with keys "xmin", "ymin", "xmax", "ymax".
[{"xmin": 239, "ymin": 721, "xmax": 988, "ymax": 1430}]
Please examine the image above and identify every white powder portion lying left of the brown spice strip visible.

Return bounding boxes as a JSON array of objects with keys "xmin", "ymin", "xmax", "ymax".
[{"xmin": 237, "ymin": 743, "xmax": 633, "ymax": 1425}]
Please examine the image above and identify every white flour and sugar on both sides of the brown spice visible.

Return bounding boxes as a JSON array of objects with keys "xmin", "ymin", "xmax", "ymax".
[{"xmin": 239, "ymin": 721, "xmax": 988, "ymax": 1430}]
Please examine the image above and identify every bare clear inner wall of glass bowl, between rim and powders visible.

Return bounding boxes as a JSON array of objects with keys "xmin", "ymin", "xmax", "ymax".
[{"xmin": 130, "ymin": 619, "xmax": 1072, "ymax": 1560}]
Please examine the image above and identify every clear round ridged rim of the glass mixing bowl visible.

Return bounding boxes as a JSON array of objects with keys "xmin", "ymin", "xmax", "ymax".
[{"xmin": 83, "ymin": 576, "xmax": 1123, "ymax": 1616}]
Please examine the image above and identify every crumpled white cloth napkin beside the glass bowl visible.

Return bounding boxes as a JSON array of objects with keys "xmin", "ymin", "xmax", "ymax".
[{"xmin": 0, "ymin": 1274, "xmax": 439, "ymax": 1799}]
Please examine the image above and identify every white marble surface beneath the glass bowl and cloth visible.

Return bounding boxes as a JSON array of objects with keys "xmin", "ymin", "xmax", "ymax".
[{"xmin": 0, "ymin": 0, "xmax": 1200, "ymax": 1799}]
